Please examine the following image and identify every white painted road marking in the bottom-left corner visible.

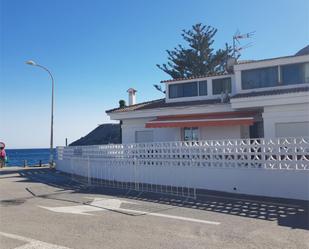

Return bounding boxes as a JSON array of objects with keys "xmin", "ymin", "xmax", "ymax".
[{"xmin": 0, "ymin": 232, "xmax": 70, "ymax": 249}]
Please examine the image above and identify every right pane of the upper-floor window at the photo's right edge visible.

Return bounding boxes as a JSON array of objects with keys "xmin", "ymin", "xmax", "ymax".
[{"xmin": 281, "ymin": 62, "xmax": 309, "ymax": 85}]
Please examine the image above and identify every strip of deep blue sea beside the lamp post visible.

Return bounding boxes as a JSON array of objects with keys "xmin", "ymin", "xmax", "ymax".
[{"xmin": 5, "ymin": 149, "xmax": 56, "ymax": 167}]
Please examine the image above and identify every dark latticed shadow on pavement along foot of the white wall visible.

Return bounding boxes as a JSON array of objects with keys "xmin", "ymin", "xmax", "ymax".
[{"xmin": 0, "ymin": 168, "xmax": 309, "ymax": 230}]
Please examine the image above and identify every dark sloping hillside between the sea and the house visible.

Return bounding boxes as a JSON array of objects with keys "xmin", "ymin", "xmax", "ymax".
[{"xmin": 69, "ymin": 124, "xmax": 120, "ymax": 146}]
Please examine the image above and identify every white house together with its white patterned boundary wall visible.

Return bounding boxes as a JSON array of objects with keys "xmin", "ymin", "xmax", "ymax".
[{"xmin": 56, "ymin": 47, "xmax": 309, "ymax": 201}]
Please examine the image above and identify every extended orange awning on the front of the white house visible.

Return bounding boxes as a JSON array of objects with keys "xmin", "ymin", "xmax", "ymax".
[{"xmin": 145, "ymin": 112, "xmax": 257, "ymax": 128}]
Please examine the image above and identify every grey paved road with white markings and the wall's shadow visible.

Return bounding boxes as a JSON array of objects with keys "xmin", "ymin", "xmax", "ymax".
[{"xmin": 0, "ymin": 168, "xmax": 309, "ymax": 249}]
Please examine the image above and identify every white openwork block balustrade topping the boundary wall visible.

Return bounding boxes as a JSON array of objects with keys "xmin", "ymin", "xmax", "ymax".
[{"xmin": 57, "ymin": 137, "xmax": 309, "ymax": 170}]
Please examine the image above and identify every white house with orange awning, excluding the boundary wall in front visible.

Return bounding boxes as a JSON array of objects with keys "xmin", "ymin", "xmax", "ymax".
[{"xmin": 106, "ymin": 48, "xmax": 309, "ymax": 143}]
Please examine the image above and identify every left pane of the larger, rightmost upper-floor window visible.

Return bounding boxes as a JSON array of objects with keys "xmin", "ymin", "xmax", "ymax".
[{"xmin": 241, "ymin": 66, "xmax": 278, "ymax": 89}]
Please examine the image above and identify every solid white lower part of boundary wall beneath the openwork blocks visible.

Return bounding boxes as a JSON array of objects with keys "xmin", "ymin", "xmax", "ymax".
[{"xmin": 56, "ymin": 159, "xmax": 309, "ymax": 200}]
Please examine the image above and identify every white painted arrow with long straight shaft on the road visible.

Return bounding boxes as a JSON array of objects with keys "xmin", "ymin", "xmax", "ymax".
[{"xmin": 39, "ymin": 198, "xmax": 220, "ymax": 225}]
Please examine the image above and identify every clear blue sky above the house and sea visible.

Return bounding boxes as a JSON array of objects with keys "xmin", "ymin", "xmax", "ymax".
[{"xmin": 0, "ymin": 0, "xmax": 309, "ymax": 148}]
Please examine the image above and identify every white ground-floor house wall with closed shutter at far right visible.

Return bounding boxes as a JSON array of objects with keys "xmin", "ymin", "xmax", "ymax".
[{"xmin": 263, "ymin": 103, "xmax": 309, "ymax": 138}]
